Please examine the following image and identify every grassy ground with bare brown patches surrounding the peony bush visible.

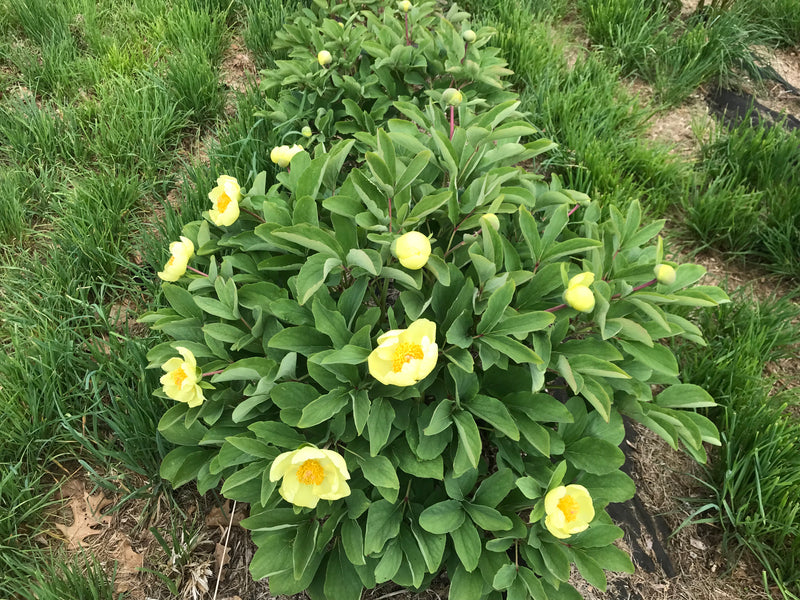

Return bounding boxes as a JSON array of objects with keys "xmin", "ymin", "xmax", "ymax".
[{"xmin": 0, "ymin": 0, "xmax": 800, "ymax": 600}]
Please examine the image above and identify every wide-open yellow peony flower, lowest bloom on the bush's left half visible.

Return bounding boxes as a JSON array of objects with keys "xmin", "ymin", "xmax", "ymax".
[{"xmin": 269, "ymin": 446, "xmax": 350, "ymax": 508}]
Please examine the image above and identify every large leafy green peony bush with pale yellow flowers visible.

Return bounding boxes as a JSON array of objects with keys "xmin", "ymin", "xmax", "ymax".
[{"xmin": 143, "ymin": 2, "xmax": 727, "ymax": 600}]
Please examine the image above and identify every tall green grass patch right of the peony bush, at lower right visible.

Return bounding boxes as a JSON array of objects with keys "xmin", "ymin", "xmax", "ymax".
[{"xmin": 680, "ymin": 288, "xmax": 800, "ymax": 598}]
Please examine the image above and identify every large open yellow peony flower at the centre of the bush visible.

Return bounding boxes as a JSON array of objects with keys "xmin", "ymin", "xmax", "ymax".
[{"xmin": 367, "ymin": 319, "xmax": 439, "ymax": 387}]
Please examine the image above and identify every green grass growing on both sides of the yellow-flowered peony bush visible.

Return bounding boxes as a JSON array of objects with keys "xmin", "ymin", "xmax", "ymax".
[{"xmin": 0, "ymin": 0, "xmax": 800, "ymax": 599}]
